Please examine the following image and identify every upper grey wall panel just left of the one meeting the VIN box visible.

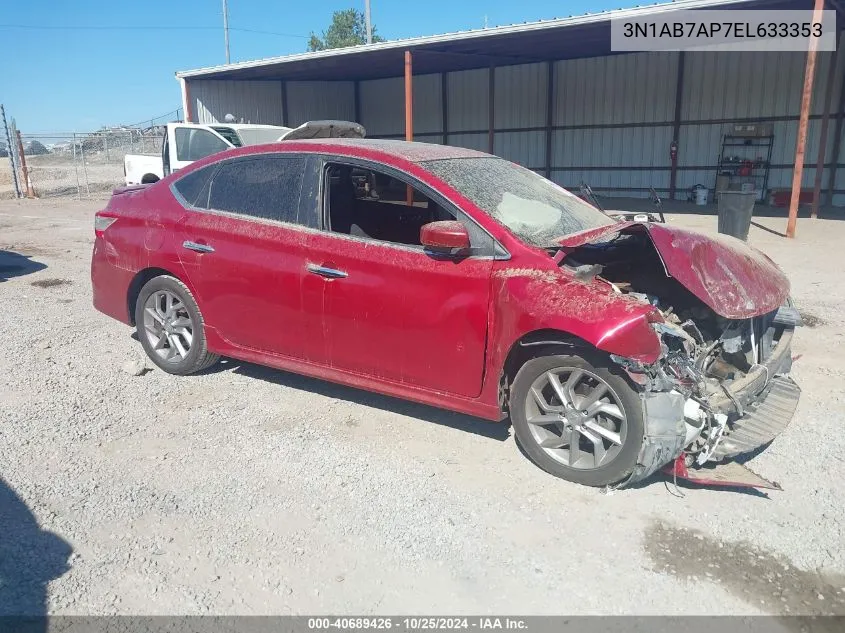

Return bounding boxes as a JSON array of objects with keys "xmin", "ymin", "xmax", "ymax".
[{"xmin": 488, "ymin": 64, "xmax": 548, "ymax": 129}]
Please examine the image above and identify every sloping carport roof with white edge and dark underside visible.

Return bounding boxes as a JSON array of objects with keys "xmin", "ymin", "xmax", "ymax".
[{"xmin": 176, "ymin": 0, "xmax": 810, "ymax": 80}]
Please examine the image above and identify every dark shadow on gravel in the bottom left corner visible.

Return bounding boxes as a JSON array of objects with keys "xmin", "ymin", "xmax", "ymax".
[{"xmin": 0, "ymin": 478, "xmax": 73, "ymax": 616}]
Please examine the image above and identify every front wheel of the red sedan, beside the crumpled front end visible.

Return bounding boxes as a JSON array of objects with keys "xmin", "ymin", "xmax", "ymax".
[{"xmin": 510, "ymin": 353, "xmax": 644, "ymax": 486}]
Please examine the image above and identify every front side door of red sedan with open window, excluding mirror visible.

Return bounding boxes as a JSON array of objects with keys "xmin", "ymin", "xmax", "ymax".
[{"xmin": 303, "ymin": 159, "xmax": 493, "ymax": 397}]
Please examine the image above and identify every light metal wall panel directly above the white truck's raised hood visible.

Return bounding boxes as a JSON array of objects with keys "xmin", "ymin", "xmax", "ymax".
[{"xmin": 287, "ymin": 81, "xmax": 355, "ymax": 127}]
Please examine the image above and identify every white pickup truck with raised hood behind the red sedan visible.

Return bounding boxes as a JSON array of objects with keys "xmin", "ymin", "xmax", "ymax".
[{"xmin": 123, "ymin": 121, "xmax": 367, "ymax": 185}]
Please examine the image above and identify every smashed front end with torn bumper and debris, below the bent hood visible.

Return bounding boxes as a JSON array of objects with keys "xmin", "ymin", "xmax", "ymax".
[{"xmin": 616, "ymin": 305, "xmax": 801, "ymax": 483}]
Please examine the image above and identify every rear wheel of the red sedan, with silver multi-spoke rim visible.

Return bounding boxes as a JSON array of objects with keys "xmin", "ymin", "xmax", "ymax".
[{"xmin": 135, "ymin": 275, "xmax": 220, "ymax": 376}]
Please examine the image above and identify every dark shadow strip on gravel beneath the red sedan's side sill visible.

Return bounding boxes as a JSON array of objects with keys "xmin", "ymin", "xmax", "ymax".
[{"xmin": 208, "ymin": 359, "xmax": 509, "ymax": 442}]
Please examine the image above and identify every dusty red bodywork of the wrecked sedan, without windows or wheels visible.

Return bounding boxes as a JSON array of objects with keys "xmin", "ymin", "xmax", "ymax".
[{"xmin": 92, "ymin": 139, "xmax": 789, "ymax": 480}]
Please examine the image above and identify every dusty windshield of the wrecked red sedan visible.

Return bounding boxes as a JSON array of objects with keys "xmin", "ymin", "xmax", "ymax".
[{"xmin": 421, "ymin": 157, "xmax": 616, "ymax": 247}]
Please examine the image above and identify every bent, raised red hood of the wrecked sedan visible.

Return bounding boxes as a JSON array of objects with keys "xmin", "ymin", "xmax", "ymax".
[{"xmin": 558, "ymin": 222, "xmax": 789, "ymax": 319}]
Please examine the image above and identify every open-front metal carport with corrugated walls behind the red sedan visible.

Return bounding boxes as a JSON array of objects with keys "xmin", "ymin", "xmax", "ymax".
[{"xmin": 177, "ymin": 0, "xmax": 845, "ymax": 236}]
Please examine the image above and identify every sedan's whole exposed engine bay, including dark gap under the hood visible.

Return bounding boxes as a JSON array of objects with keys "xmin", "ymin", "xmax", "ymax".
[{"xmin": 558, "ymin": 230, "xmax": 801, "ymax": 483}]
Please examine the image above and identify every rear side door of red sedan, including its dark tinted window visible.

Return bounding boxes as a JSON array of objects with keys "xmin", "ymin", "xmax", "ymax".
[{"xmin": 174, "ymin": 154, "xmax": 316, "ymax": 358}]
